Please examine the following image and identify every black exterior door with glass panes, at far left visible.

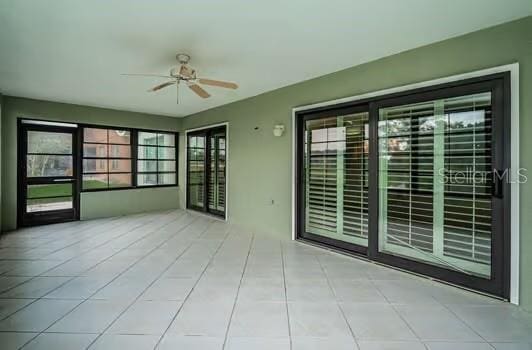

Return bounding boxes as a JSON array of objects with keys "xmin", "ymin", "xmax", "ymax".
[{"xmin": 18, "ymin": 121, "xmax": 79, "ymax": 226}]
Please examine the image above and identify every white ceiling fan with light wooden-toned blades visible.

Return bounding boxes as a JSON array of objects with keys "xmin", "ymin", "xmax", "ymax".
[{"xmin": 122, "ymin": 53, "xmax": 238, "ymax": 103}]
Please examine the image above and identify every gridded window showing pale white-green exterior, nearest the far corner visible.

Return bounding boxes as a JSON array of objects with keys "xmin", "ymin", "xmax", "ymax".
[{"xmin": 137, "ymin": 131, "xmax": 177, "ymax": 187}]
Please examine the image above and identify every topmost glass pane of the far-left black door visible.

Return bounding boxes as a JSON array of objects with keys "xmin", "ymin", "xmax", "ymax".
[{"xmin": 28, "ymin": 131, "xmax": 72, "ymax": 154}]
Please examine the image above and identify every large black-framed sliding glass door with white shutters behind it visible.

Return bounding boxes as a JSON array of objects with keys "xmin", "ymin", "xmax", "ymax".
[{"xmin": 297, "ymin": 74, "xmax": 510, "ymax": 297}]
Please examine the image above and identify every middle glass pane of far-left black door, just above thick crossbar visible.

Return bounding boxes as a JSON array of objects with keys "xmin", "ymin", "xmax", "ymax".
[{"xmin": 27, "ymin": 154, "xmax": 73, "ymax": 177}]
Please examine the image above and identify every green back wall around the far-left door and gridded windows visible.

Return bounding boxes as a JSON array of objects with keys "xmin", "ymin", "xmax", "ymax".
[{"xmin": 1, "ymin": 96, "xmax": 181, "ymax": 231}]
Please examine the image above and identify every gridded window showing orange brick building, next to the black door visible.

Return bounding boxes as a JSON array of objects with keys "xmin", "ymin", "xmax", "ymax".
[{"xmin": 82, "ymin": 128, "xmax": 133, "ymax": 190}]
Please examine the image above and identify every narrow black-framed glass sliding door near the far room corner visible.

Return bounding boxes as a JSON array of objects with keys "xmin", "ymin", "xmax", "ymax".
[{"xmin": 187, "ymin": 126, "xmax": 227, "ymax": 218}]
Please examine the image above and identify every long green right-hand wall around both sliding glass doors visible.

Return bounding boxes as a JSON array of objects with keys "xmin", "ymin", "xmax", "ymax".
[{"xmin": 180, "ymin": 17, "xmax": 532, "ymax": 310}]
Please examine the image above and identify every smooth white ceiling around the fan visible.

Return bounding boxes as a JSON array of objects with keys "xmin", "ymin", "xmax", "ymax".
[{"xmin": 0, "ymin": 0, "xmax": 532, "ymax": 117}]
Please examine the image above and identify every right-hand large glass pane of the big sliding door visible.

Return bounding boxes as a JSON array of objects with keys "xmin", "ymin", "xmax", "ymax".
[{"xmin": 379, "ymin": 93, "xmax": 492, "ymax": 278}]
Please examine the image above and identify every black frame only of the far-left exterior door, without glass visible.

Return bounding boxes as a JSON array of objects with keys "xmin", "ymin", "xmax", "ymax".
[{"xmin": 17, "ymin": 118, "xmax": 80, "ymax": 227}]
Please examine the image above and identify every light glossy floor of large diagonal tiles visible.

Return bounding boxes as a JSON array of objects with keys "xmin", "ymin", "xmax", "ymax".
[{"xmin": 0, "ymin": 210, "xmax": 532, "ymax": 350}]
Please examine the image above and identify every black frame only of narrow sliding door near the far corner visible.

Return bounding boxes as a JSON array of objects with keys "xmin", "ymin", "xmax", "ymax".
[{"xmin": 185, "ymin": 125, "xmax": 227, "ymax": 219}]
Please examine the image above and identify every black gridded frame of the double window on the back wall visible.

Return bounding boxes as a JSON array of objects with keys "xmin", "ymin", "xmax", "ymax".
[{"xmin": 78, "ymin": 123, "xmax": 179, "ymax": 193}]
